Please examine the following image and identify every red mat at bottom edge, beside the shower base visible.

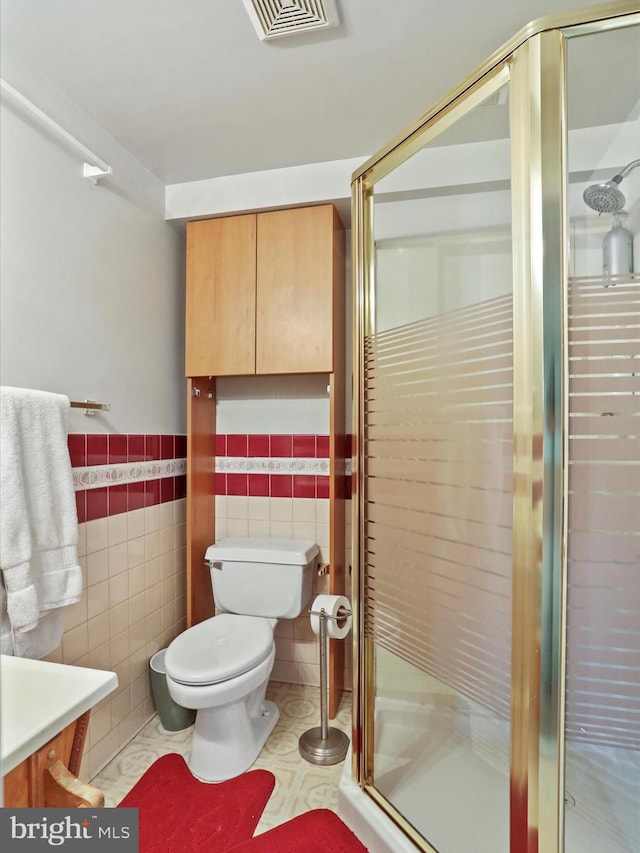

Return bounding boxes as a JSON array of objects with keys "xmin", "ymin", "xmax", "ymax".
[{"xmin": 233, "ymin": 809, "xmax": 367, "ymax": 853}]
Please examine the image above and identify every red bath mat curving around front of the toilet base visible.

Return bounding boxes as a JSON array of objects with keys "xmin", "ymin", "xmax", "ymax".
[{"xmin": 118, "ymin": 753, "xmax": 276, "ymax": 853}]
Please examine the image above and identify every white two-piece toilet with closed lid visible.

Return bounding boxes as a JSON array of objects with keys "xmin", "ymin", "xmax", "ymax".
[{"xmin": 164, "ymin": 538, "xmax": 319, "ymax": 782}]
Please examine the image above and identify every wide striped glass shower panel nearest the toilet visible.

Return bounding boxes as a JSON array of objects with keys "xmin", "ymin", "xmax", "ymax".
[{"xmin": 364, "ymin": 80, "xmax": 513, "ymax": 853}]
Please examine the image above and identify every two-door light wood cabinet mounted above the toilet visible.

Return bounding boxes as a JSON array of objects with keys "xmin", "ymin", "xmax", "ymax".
[{"xmin": 186, "ymin": 204, "xmax": 344, "ymax": 376}]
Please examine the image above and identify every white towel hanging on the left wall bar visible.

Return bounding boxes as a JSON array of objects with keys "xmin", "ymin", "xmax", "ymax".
[{"xmin": 0, "ymin": 387, "xmax": 82, "ymax": 657}]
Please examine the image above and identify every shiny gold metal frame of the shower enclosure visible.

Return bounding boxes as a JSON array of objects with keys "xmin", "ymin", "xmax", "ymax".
[{"xmin": 352, "ymin": 2, "xmax": 640, "ymax": 853}]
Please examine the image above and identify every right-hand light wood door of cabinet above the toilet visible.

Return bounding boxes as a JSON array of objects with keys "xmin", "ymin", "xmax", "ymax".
[{"xmin": 256, "ymin": 205, "xmax": 344, "ymax": 373}]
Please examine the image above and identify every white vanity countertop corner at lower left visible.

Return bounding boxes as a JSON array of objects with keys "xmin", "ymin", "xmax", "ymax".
[{"xmin": 0, "ymin": 655, "xmax": 118, "ymax": 775}]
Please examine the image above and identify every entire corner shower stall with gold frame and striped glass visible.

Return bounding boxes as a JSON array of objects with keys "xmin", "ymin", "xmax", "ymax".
[{"xmin": 339, "ymin": 3, "xmax": 640, "ymax": 853}]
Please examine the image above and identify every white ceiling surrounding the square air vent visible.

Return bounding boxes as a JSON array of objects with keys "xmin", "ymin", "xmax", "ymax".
[{"xmin": 0, "ymin": 0, "xmax": 632, "ymax": 184}]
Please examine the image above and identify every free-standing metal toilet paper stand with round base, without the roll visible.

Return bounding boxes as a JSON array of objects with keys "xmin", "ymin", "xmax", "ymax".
[{"xmin": 298, "ymin": 607, "xmax": 351, "ymax": 765}]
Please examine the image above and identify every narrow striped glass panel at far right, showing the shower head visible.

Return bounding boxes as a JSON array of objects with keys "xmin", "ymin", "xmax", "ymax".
[{"xmin": 565, "ymin": 26, "xmax": 640, "ymax": 853}]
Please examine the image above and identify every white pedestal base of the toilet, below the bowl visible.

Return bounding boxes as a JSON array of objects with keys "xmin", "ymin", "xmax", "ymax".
[{"xmin": 187, "ymin": 696, "xmax": 280, "ymax": 782}]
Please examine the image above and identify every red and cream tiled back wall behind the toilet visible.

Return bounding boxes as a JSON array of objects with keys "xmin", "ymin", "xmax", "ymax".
[{"xmin": 216, "ymin": 434, "xmax": 352, "ymax": 690}]
